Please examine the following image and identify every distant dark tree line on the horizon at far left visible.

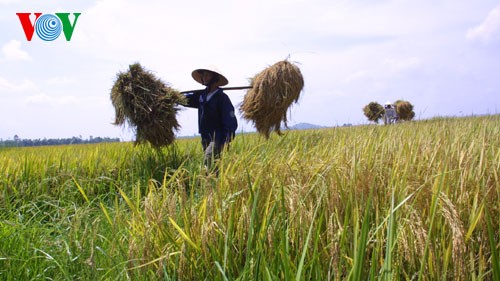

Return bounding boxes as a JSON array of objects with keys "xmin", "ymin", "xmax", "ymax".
[{"xmin": 0, "ymin": 135, "xmax": 120, "ymax": 147}]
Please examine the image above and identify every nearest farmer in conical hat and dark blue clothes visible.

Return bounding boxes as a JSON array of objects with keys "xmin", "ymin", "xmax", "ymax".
[{"xmin": 185, "ymin": 67, "xmax": 238, "ymax": 174}]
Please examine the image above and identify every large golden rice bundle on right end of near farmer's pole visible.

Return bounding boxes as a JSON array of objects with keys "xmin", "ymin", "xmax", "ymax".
[{"xmin": 240, "ymin": 60, "xmax": 304, "ymax": 138}]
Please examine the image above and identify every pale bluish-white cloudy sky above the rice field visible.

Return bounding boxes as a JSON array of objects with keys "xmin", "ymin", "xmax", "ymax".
[{"xmin": 0, "ymin": 0, "xmax": 500, "ymax": 141}]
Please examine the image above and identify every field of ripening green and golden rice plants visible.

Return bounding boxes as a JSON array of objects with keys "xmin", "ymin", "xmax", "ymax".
[{"xmin": 0, "ymin": 115, "xmax": 500, "ymax": 280}]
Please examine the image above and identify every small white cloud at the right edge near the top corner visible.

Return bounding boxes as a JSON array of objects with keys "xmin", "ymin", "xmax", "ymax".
[{"xmin": 466, "ymin": 5, "xmax": 500, "ymax": 44}]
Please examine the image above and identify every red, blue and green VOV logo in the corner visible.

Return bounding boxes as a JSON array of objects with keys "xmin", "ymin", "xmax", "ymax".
[{"xmin": 16, "ymin": 13, "xmax": 81, "ymax": 41}]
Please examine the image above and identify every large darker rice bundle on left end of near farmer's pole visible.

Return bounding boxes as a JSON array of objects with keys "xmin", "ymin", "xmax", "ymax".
[{"xmin": 111, "ymin": 63, "xmax": 185, "ymax": 148}]
